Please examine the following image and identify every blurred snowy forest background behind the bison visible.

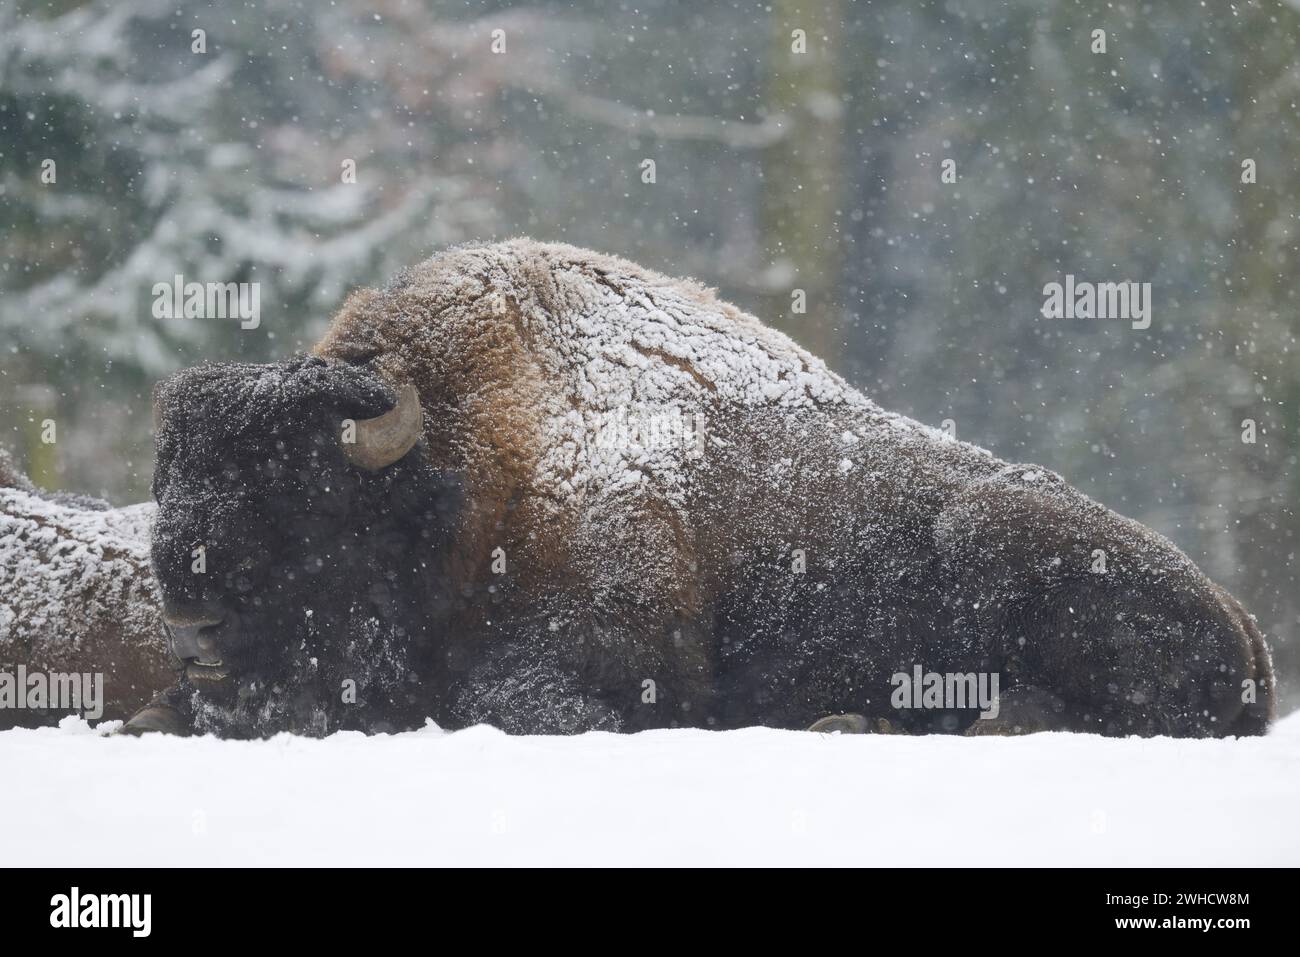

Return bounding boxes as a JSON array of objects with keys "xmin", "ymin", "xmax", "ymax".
[{"xmin": 0, "ymin": 0, "xmax": 1300, "ymax": 701}]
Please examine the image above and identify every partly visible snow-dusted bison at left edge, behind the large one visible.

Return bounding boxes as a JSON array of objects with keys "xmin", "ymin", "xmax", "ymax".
[{"xmin": 0, "ymin": 450, "xmax": 173, "ymax": 729}]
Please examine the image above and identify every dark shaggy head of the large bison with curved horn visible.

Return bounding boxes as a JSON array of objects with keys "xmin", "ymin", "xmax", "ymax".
[{"xmin": 152, "ymin": 356, "xmax": 458, "ymax": 736}]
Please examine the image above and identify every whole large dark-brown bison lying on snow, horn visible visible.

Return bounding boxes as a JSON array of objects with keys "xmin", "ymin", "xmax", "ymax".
[{"xmin": 131, "ymin": 241, "xmax": 1271, "ymax": 736}]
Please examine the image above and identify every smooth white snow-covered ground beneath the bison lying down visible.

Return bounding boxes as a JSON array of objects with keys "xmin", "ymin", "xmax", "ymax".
[{"xmin": 0, "ymin": 714, "xmax": 1300, "ymax": 866}]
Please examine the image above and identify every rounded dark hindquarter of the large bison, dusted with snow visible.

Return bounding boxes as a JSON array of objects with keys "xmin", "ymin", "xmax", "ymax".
[{"xmin": 936, "ymin": 472, "xmax": 1271, "ymax": 737}]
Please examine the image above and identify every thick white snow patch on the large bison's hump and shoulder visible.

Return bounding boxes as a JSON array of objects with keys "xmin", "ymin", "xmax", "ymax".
[{"xmin": 524, "ymin": 252, "xmax": 881, "ymax": 506}]
